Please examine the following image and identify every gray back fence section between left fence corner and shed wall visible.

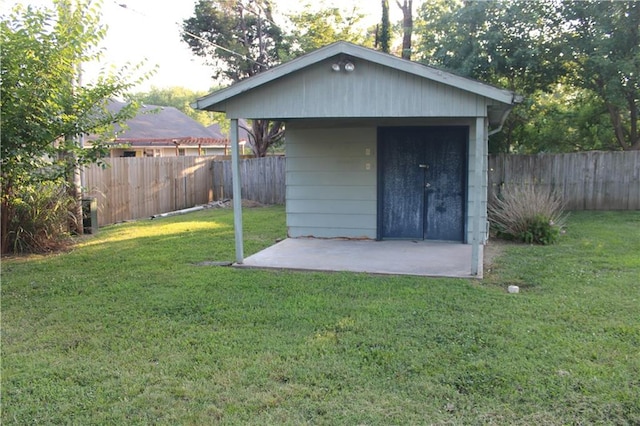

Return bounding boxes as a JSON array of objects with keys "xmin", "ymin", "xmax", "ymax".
[{"xmin": 213, "ymin": 156, "xmax": 286, "ymax": 204}]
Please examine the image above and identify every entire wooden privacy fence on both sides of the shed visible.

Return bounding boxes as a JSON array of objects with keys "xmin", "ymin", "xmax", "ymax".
[{"xmin": 84, "ymin": 151, "xmax": 640, "ymax": 226}]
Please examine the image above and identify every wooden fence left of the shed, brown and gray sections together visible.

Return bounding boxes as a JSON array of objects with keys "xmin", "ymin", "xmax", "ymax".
[{"xmin": 84, "ymin": 156, "xmax": 285, "ymax": 226}]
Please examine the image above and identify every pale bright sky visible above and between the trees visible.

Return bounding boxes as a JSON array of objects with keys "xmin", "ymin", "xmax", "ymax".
[{"xmin": 0, "ymin": 0, "xmax": 400, "ymax": 92}]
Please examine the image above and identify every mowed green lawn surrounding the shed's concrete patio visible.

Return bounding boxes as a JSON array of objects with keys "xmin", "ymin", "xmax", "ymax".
[{"xmin": 2, "ymin": 207, "xmax": 640, "ymax": 425}]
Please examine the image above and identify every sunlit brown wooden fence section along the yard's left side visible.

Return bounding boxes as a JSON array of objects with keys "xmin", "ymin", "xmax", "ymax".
[{"xmin": 84, "ymin": 156, "xmax": 213, "ymax": 226}]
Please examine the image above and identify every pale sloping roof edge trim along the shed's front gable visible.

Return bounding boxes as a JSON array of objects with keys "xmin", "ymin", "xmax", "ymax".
[{"xmin": 192, "ymin": 41, "xmax": 522, "ymax": 112}]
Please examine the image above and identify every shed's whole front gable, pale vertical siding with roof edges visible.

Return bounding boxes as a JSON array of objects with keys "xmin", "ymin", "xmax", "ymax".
[{"xmin": 193, "ymin": 42, "xmax": 518, "ymax": 123}]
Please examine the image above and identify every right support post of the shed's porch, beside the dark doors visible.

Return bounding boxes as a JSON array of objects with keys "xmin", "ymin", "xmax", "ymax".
[{"xmin": 471, "ymin": 117, "xmax": 486, "ymax": 276}]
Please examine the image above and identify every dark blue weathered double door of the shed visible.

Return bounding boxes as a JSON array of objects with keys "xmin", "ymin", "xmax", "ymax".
[{"xmin": 378, "ymin": 126, "xmax": 469, "ymax": 241}]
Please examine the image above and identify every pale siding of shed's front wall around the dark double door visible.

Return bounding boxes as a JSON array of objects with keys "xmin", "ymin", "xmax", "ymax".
[{"xmin": 286, "ymin": 119, "xmax": 487, "ymax": 242}]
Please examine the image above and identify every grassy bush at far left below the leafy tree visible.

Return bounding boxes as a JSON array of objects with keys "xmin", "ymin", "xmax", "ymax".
[{"xmin": 8, "ymin": 182, "xmax": 74, "ymax": 253}]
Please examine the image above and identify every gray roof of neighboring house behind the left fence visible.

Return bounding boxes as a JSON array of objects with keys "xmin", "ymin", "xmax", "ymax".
[{"xmin": 88, "ymin": 100, "xmax": 228, "ymax": 148}]
